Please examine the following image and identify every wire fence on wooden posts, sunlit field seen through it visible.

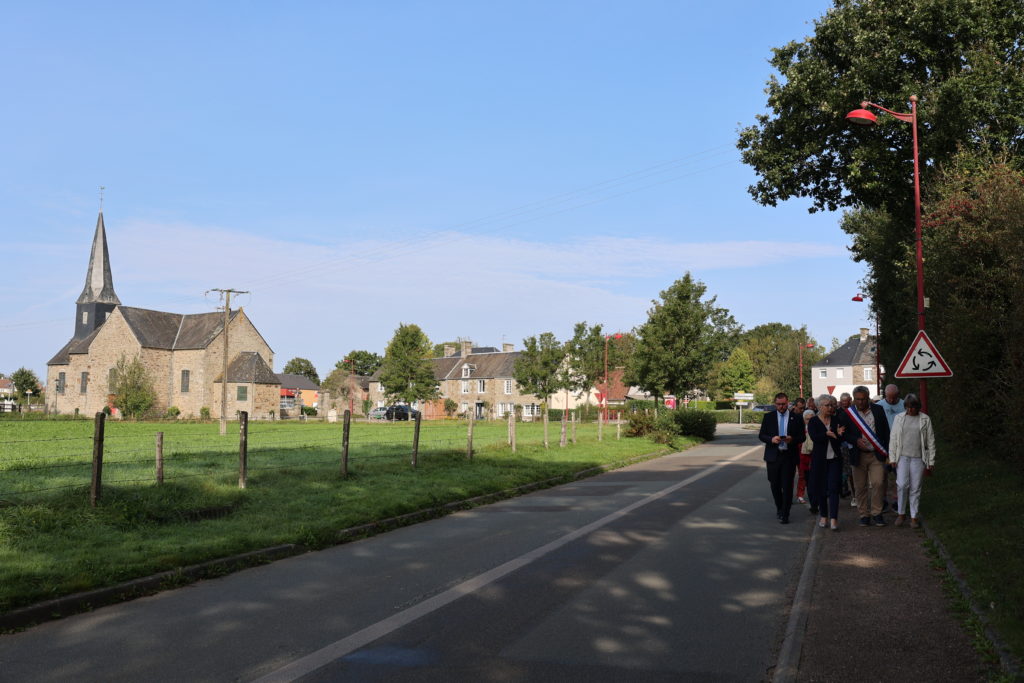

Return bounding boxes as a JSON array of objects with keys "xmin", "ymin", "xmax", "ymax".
[{"xmin": 0, "ymin": 414, "xmax": 620, "ymax": 505}]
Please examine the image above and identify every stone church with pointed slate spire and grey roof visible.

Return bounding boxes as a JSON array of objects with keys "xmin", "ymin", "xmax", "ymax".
[{"xmin": 46, "ymin": 210, "xmax": 281, "ymax": 419}]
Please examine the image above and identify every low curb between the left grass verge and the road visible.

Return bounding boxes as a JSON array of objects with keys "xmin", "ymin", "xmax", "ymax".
[{"xmin": 0, "ymin": 444, "xmax": 675, "ymax": 632}]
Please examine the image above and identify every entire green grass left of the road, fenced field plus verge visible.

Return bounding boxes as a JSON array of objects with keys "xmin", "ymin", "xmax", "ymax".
[{"xmin": 0, "ymin": 419, "xmax": 696, "ymax": 611}]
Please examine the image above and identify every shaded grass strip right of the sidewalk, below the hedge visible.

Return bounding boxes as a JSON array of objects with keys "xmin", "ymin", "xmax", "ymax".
[{"xmin": 922, "ymin": 444, "xmax": 1024, "ymax": 679}]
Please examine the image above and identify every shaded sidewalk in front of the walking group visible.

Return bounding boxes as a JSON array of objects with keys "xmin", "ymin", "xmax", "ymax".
[{"xmin": 794, "ymin": 499, "xmax": 984, "ymax": 683}]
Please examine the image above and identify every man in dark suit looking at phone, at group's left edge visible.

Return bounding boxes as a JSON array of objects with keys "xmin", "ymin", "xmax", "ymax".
[{"xmin": 758, "ymin": 391, "xmax": 804, "ymax": 524}]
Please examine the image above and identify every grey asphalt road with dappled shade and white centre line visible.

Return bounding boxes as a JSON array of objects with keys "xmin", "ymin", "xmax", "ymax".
[{"xmin": 0, "ymin": 423, "xmax": 811, "ymax": 682}]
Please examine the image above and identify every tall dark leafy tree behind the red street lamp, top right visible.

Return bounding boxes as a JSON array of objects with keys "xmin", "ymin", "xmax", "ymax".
[{"xmin": 738, "ymin": 0, "xmax": 1024, "ymax": 378}]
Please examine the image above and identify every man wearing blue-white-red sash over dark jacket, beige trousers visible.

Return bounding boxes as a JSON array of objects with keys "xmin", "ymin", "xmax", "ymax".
[{"xmin": 841, "ymin": 386, "xmax": 889, "ymax": 526}]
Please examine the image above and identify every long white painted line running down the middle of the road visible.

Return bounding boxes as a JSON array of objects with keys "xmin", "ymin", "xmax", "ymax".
[{"xmin": 255, "ymin": 445, "xmax": 764, "ymax": 683}]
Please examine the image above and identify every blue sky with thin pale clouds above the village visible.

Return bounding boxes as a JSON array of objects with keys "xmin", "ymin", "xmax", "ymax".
[{"xmin": 0, "ymin": 0, "xmax": 867, "ymax": 375}]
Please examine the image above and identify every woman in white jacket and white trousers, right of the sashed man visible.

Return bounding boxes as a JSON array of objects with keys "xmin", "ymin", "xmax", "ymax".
[{"xmin": 889, "ymin": 393, "xmax": 935, "ymax": 528}]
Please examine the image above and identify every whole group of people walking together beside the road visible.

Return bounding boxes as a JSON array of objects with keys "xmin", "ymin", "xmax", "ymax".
[{"xmin": 758, "ymin": 384, "xmax": 935, "ymax": 531}]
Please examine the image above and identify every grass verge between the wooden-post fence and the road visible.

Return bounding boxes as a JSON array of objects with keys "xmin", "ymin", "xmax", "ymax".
[{"xmin": 0, "ymin": 426, "xmax": 697, "ymax": 612}]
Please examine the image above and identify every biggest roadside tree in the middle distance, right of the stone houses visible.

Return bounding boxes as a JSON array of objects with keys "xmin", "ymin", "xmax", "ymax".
[{"xmin": 626, "ymin": 272, "xmax": 739, "ymax": 397}]
